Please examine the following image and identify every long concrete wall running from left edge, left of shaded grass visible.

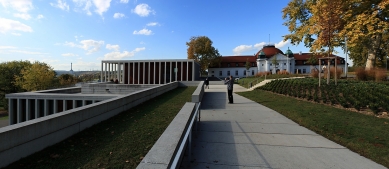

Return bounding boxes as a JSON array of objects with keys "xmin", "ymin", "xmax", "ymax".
[{"xmin": 0, "ymin": 82, "xmax": 178, "ymax": 167}]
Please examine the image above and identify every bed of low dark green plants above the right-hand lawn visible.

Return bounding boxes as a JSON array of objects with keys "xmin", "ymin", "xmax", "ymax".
[{"xmin": 260, "ymin": 78, "xmax": 389, "ymax": 113}]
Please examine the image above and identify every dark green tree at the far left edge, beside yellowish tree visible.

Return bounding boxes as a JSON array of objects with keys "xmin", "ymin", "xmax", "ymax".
[{"xmin": 0, "ymin": 61, "xmax": 31, "ymax": 109}]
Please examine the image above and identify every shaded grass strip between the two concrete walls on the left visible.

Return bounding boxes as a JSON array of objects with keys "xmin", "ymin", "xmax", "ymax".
[{"xmin": 6, "ymin": 87, "xmax": 196, "ymax": 169}]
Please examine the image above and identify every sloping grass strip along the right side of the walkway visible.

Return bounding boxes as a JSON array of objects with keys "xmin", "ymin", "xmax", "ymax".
[{"xmin": 237, "ymin": 90, "xmax": 389, "ymax": 167}]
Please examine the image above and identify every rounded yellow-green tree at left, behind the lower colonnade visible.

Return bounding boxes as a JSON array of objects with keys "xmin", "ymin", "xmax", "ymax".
[{"xmin": 15, "ymin": 62, "xmax": 55, "ymax": 91}]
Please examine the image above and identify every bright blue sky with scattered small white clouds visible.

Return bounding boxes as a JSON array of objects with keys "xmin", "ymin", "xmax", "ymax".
[{"xmin": 0, "ymin": 0, "xmax": 352, "ymax": 71}]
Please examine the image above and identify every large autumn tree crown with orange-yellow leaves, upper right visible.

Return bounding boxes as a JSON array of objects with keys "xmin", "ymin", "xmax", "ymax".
[{"xmin": 283, "ymin": 0, "xmax": 389, "ymax": 69}]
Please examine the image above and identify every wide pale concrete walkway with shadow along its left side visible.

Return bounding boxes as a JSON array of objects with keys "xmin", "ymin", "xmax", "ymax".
[{"xmin": 181, "ymin": 85, "xmax": 386, "ymax": 169}]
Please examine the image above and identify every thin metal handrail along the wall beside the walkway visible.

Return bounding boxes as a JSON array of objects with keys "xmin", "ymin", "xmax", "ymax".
[{"xmin": 170, "ymin": 102, "xmax": 201, "ymax": 169}]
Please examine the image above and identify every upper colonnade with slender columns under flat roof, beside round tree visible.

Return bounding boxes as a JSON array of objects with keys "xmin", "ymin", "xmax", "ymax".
[{"xmin": 101, "ymin": 59, "xmax": 196, "ymax": 84}]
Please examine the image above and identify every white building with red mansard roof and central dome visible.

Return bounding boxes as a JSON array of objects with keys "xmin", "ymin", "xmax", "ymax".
[{"xmin": 208, "ymin": 44, "xmax": 347, "ymax": 78}]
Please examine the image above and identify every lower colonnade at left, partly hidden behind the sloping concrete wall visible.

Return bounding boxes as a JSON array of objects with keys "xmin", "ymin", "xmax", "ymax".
[{"xmin": 8, "ymin": 98, "xmax": 101, "ymax": 125}]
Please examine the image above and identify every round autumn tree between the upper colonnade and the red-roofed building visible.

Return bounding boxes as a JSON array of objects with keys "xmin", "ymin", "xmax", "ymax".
[{"xmin": 186, "ymin": 36, "xmax": 221, "ymax": 74}]
